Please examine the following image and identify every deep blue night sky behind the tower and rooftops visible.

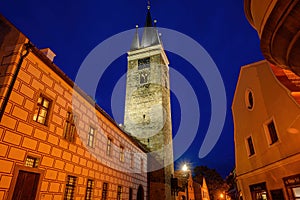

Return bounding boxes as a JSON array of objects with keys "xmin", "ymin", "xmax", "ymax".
[{"xmin": 0, "ymin": 0, "xmax": 263, "ymax": 177}]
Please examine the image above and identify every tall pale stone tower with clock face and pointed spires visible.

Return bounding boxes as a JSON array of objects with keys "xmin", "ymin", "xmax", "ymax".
[{"xmin": 124, "ymin": 5, "xmax": 174, "ymax": 199}]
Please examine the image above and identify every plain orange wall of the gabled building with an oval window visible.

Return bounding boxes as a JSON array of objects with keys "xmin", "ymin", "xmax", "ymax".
[{"xmin": 232, "ymin": 61, "xmax": 300, "ymax": 199}]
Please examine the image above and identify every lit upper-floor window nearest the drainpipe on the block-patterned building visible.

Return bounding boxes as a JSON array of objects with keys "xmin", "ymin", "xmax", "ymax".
[{"xmin": 33, "ymin": 96, "xmax": 50, "ymax": 125}]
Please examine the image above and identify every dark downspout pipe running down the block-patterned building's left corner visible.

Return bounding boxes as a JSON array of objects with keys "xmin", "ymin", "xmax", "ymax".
[{"xmin": 0, "ymin": 42, "xmax": 32, "ymax": 122}]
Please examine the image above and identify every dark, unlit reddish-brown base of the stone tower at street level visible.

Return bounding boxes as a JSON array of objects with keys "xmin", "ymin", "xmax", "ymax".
[{"xmin": 148, "ymin": 154, "xmax": 175, "ymax": 200}]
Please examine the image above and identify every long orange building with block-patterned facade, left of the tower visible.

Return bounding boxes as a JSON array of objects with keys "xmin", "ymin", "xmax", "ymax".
[{"xmin": 0, "ymin": 15, "xmax": 148, "ymax": 200}]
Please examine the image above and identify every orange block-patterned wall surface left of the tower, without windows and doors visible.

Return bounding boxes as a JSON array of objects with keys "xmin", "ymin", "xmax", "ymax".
[{"xmin": 0, "ymin": 14, "xmax": 147, "ymax": 200}]
